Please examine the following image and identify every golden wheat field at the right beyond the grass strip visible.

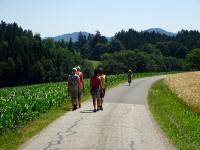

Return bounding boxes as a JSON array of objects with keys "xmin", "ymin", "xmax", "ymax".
[{"xmin": 165, "ymin": 71, "xmax": 200, "ymax": 112}]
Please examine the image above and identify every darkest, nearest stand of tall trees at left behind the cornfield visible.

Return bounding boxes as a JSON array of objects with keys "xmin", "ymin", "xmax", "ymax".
[{"xmin": 0, "ymin": 21, "xmax": 93, "ymax": 87}]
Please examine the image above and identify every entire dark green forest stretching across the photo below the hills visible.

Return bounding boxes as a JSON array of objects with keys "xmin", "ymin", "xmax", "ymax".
[{"xmin": 0, "ymin": 21, "xmax": 200, "ymax": 87}]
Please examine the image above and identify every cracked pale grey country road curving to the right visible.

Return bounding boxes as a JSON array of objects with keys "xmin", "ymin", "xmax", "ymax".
[{"xmin": 20, "ymin": 76, "xmax": 172, "ymax": 150}]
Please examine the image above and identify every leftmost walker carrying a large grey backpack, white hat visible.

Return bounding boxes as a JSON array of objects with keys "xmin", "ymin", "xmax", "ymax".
[{"xmin": 68, "ymin": 68, "xmax": 80, "ymax": 111}]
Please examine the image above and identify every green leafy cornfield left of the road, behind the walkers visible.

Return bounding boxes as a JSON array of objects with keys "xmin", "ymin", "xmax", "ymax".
[{"xmin": 0, "ymin": 74, "xmax": 127, "ymax": 131}]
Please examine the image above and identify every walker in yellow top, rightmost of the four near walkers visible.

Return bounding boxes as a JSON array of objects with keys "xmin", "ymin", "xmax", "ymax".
[{"xmin": 99, "ymin": 68, "xmax": 108, "ymax": 110}]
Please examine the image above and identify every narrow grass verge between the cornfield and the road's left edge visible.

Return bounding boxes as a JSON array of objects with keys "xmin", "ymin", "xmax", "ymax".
[{"xmin": 0, "ymin": 72, "xmax": 177, "ymax": 150}]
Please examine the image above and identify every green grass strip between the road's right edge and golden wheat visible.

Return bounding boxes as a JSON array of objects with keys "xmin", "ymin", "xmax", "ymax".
[{"xmin": 148, "ymin": 80, "xmax": 200, "ymax": 150}]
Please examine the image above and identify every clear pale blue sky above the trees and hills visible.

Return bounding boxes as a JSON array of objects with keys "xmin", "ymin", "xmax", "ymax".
[{"xmin": 0, "ymin": 0, "xmax": 200, "ymax": 37}]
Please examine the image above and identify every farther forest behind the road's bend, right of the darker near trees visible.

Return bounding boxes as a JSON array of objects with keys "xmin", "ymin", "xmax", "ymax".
[{"xmin": 66, "ymin": 29, "xmax": 200, "ymax": 74}]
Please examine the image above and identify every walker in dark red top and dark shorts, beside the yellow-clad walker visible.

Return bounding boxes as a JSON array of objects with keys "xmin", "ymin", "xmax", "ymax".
[{"xmin": 90, "ymin": 69, "xmax": 101, "ymax": 112}]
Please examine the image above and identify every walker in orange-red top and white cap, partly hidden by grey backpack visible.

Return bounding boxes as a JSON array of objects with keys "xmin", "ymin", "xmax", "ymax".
[{"xmin": 76, "ymin": 66, "xmax": 84, "ymax": 108}]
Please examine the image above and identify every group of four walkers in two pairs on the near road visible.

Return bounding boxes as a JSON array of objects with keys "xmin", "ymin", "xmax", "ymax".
[{"xmin": 68, "ymin": 66, "xmax": 107, "ymax": 112}]
